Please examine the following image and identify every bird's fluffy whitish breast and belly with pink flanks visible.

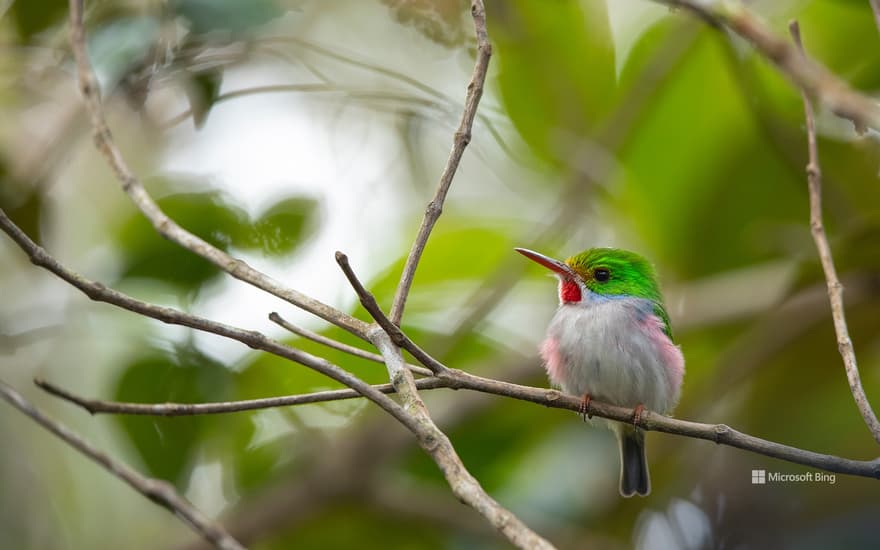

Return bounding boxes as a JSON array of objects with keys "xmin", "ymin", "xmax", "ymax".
[{"xmin": 541, "ymin": 297, "xmax": 684, "ymax": 413}]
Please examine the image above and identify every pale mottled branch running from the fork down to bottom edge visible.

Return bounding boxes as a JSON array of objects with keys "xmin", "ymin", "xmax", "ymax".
[{"xmin": 336, "ymin": 252, "xmax": 553, "ymax": 550}]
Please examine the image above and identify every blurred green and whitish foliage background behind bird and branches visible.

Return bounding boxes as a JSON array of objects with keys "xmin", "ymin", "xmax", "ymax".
[{"xmin": 0, "ymin": 0, "xmax": 880, "ymax": 549}]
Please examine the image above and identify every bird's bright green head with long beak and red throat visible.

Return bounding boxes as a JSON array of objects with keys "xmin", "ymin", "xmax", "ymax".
[{"xmin": 516, "ymin": 248, "xmax": 669, "ymax": 333}]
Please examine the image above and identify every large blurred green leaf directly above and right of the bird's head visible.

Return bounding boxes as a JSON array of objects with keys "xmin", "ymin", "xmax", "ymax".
[{"xmin": 613, "ymin": 33, "xmax": 806, "ymax": 277}]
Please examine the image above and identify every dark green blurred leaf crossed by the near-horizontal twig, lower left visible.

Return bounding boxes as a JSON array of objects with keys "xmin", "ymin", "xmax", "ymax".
[{"xmin": 113, "ymin": 346, "xmax": 234, "ymax": 486}]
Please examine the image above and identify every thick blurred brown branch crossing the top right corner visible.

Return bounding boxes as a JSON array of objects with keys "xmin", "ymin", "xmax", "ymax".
[{"xmin": 655, "ymin": 0, "xmax": 880, "ymax": 133}]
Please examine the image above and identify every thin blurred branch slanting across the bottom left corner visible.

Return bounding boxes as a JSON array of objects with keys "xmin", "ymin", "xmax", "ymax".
[{"xmin": 0, "ymin": 381, "xmax": 244, "ymax": 550}]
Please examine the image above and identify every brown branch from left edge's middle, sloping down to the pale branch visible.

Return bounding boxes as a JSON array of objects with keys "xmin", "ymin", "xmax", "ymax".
[{"xmin": 0, "ymin": 209, "xmax": 415, "ymax": 436}]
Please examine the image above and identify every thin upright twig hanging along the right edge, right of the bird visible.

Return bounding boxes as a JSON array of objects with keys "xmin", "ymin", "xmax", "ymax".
[{"xmin": 789, "ymin": 21, "xmax": 880, "ymax": 443}]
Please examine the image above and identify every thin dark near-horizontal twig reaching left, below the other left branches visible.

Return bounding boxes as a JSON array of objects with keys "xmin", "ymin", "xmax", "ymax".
[{"xmin": 34, "ymin": 378, "xmax": 447, "ymax": 416}]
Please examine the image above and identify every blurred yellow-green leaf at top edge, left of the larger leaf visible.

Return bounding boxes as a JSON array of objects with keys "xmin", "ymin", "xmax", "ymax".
[{"xmin": 488, "ymin": 0, "xmax": 616, "ymax": 163}]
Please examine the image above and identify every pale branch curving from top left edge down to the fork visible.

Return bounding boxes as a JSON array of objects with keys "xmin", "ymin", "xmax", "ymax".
[{"xmin": 70, "ymin": 0, "xmax": 367, "ymax": 338}]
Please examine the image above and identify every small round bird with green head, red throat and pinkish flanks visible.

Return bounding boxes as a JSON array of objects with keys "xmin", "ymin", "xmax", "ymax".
[{"xmin": 515, "ymin": 248, "xmax": 684, "ymax": 497}]
